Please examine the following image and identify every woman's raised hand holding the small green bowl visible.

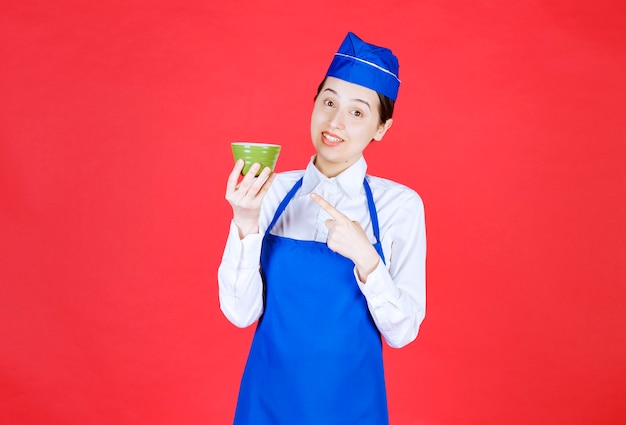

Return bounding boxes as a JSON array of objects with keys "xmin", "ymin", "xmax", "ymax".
[{"xmin": 226, "ymin": 159, "xmax": 276, "ymax": 239}]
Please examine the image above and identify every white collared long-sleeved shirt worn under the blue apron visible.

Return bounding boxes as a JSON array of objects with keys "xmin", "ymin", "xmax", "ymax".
[{"xmin": 218, "ymin": 157, "xmax": 426, "ymax": 347}]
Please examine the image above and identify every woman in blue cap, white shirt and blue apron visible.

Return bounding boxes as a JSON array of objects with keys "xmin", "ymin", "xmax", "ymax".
[{"xmin": 218, "ymin": 33, "xmax": 426, "ymax": 425}]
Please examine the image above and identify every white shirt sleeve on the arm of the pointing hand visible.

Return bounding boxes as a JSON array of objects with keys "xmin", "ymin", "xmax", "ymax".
[{"xmin": 354, "ymin": 189, "xmax": 426, "ymax": 348}]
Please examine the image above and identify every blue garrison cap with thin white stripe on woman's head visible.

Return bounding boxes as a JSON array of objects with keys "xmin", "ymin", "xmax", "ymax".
[{"xmin": 326, "ymin": 32, "xmax": 400, "ymax": 101}]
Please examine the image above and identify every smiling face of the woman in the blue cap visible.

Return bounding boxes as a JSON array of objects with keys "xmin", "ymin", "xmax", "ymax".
[{"xmin": 311, "ymin": 77, "xmax": 392, "ymax": 177}]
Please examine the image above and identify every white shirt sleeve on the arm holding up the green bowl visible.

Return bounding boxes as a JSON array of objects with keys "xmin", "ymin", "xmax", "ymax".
[{"xmin": 217, "ymin": 221, "xmax": 263, "ymax": 328}]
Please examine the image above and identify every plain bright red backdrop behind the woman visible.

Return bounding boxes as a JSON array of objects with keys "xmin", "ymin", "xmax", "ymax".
[{"xmin": 0, "ymin": 0, "xmax": 626, "ymax": 425}]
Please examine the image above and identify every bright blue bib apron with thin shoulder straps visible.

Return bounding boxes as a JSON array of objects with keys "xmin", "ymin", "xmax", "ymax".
[{"xmin": 234, "ymin": 179, "xmax": 388, "ymax": 425}]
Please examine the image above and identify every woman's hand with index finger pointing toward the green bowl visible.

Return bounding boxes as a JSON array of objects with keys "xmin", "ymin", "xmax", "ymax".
[{"xmin": 311, "ymin": 193, "xmax": 380, "ymax": 283}]
